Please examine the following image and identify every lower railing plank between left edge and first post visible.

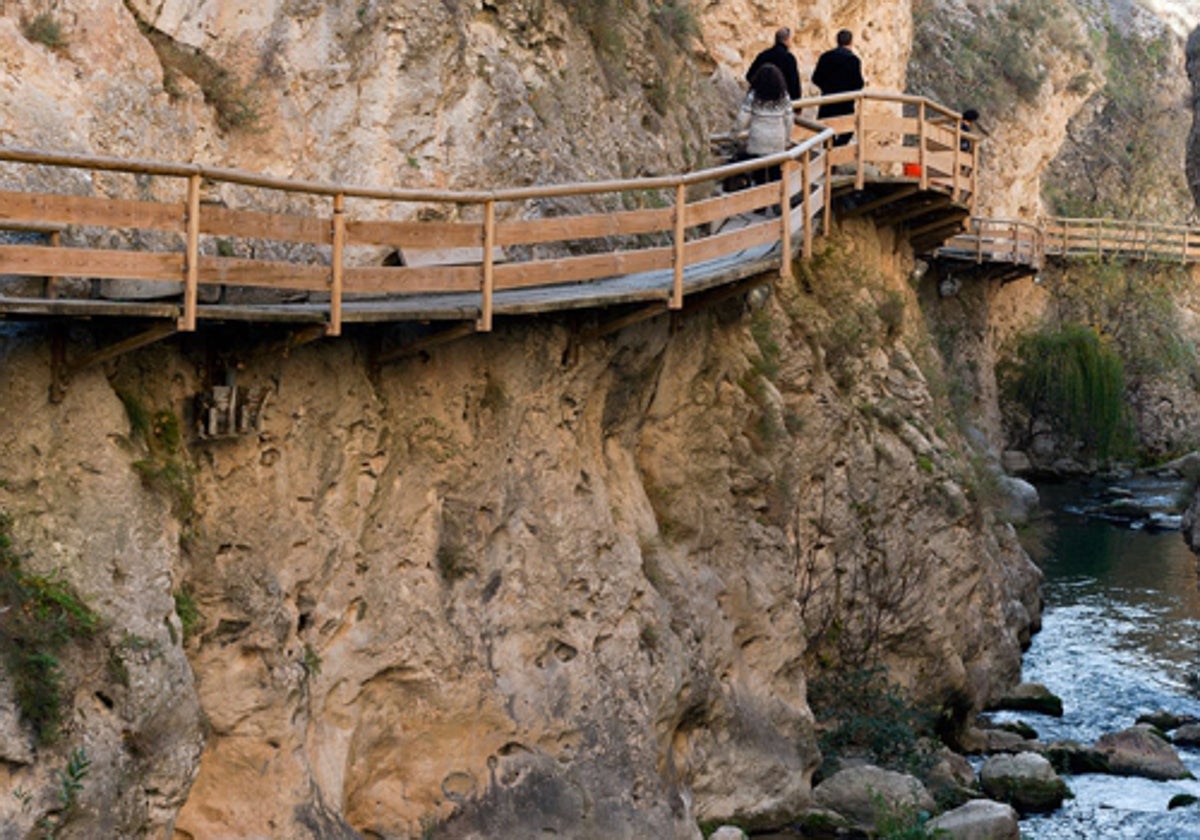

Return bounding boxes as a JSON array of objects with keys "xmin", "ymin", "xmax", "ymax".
[{"xmin": 0, "ymin": 245, "xmax": 184, "ymax": 283}]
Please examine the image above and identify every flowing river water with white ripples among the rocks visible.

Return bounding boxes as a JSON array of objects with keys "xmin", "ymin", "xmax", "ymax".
[{"xmin": 997, "ymin": 480, "xmax": 1200, "ymax": 840}]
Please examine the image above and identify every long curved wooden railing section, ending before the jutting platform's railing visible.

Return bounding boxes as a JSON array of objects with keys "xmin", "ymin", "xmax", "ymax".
[{"xmin": 0, "ymin": 141, "xmax": 828, "ymax": 335}]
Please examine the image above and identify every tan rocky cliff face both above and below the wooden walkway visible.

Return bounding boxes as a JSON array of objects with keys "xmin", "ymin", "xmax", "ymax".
[{"xmin": 0, "ymin": 0, "xmax": 1180, "ymax": 838}]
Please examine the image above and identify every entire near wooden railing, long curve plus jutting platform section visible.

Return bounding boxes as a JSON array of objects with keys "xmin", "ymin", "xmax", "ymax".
[{"xmin": 0, "ymin": 91, "xmax": 977, "ymax": 335}]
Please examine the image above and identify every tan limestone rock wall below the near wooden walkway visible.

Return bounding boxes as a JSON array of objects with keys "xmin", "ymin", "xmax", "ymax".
[{"xmin": 0, "ymin": 228, "xmax": 1038, "ymax": 838}]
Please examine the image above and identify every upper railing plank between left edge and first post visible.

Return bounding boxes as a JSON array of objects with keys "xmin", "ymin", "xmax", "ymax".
[{"xmin": 0, "ymin": 191, "xmax": 187, "ymax": 234}]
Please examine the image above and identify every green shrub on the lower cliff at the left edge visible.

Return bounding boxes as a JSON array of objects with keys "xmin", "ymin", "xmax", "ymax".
[{"xmin": 0, "ymin": 514, "xmax": 100, "ymax": 744}]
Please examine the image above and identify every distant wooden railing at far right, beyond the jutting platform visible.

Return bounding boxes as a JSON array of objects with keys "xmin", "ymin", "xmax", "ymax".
[{"xmin": 936, "ymin": 217, "xmax": 1200, "ymax": 268}]
